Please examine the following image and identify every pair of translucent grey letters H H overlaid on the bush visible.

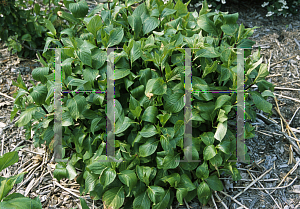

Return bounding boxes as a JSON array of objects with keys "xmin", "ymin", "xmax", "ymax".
[{"xmin": 52, "ymin": 48, "xmax": 252, "ymax": 163}]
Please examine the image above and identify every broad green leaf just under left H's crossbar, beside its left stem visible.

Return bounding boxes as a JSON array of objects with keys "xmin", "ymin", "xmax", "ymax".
[{"xmin": 67, "ymin": 95, "xmax": 87, "ymax": 121}]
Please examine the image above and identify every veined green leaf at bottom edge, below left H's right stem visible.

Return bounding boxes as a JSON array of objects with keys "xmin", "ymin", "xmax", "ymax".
[{"xmin": 102, "ymin": 186, "xmax": 125, "ymax": 209}]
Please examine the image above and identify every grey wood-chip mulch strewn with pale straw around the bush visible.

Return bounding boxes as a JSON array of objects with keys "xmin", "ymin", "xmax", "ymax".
[{"xmin": 0, "ymin": 1, "xmax": 300, "ymax": 209}]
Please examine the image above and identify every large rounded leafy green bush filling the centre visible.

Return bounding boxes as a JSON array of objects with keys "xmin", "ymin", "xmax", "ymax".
[{"xmin": 11, "ymin": 0, "xmax": 274, "ymax": 209}]
